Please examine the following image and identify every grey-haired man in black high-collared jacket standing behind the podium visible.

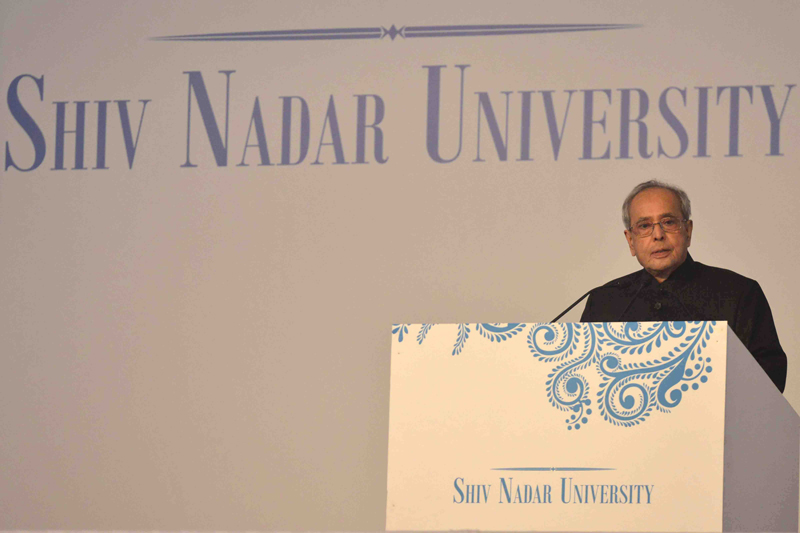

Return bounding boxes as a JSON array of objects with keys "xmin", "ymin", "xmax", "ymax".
[{"xmin": 581, "ymin": 181, "xmax": 786, "ymax": 392}]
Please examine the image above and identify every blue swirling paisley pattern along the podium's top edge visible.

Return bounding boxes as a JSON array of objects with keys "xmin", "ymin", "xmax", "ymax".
[{"xmin": 392, "ymin": 322, "xmax": 716, "ymax": 430}]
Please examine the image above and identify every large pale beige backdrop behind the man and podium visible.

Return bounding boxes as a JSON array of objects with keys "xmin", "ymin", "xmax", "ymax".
[{"xmin": 0, "ymin": 1, "xmax": 800, "ymax": 530}]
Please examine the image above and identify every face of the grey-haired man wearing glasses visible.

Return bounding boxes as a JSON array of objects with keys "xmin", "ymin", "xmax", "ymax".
[{"xmin": 625, "ymin": 188, "xmax": 692, "ymax": 282}]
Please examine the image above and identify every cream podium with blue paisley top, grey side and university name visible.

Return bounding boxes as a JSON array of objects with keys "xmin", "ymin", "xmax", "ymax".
[{"xmin": 386, "ymin": 322, "xmax": 800, "ymax": 531}]
